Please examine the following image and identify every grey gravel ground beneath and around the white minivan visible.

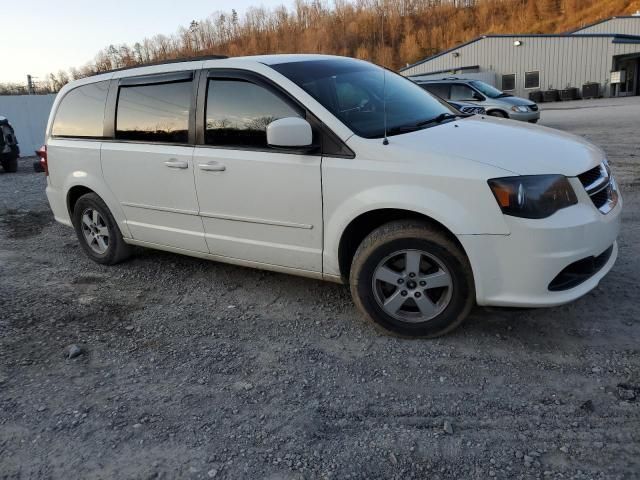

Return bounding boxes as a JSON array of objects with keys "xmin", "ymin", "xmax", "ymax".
[{"xmin": 0, "ymin": 100, "xmax": 640, "ymax": 479}]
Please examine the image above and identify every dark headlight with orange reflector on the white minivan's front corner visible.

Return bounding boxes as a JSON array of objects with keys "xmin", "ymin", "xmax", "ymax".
[{"xmin": 488, "ymin": 175, "xmax": 578, "ymax": 218}]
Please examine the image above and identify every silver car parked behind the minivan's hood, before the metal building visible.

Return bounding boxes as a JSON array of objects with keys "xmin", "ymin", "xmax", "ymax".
[{"xmin": 416, "ymin": 77, "xmax": 540, "ymax": 123}]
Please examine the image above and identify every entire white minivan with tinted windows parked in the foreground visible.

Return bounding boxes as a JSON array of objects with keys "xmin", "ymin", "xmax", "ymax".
[{"xmin": 41, "ymin": 55, "xmax": 622, "ymax": 337}]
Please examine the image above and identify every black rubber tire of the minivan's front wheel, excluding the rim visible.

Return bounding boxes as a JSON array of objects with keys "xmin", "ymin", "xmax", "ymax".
[{"xmin": 349, "ymin": 220, "xmax": 475, "ymax": 338}]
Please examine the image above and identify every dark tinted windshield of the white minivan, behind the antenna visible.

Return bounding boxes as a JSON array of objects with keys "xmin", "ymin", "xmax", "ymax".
[{"xmin": 271, "ymin": 58, "xmax": 452, "ymax": 138}]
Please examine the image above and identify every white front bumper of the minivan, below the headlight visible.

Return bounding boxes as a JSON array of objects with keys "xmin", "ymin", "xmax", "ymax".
[{"xmin": 458, "ymin": 191, "xmax": 622, "ymax": 307}]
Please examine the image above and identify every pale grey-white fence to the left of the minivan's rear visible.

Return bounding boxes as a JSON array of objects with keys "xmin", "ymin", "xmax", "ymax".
[{"xmin": 0, "ymin": 95, "xmax": 56, "ymax": 157}]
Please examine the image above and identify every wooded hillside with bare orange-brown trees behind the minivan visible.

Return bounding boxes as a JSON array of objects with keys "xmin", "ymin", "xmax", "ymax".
[{"xmin": 2, "ymin": 0, "xmax": 640, "ymax": 91}]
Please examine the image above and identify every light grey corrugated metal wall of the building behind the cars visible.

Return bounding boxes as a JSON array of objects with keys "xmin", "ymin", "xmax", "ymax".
[{"xmin": 401, "ymin": 35, "xmax": 640, "ymax": 97}]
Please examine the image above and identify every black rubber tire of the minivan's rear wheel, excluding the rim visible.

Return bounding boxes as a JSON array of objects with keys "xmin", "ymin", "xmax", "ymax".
[{"xmin": 73, "ymin": 193, "xmax": 132, "ymax": 265}]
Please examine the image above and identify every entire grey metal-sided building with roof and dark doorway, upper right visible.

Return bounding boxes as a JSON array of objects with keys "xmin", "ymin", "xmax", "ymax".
[{"xmin": 400, "ymin": 16, "xmax": 640, "ymax": 97}]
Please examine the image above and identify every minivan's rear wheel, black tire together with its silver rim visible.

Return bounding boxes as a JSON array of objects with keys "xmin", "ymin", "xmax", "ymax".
[{"xmin": 73, "ymin": 193, "xmax": 131, "ymax": 265}]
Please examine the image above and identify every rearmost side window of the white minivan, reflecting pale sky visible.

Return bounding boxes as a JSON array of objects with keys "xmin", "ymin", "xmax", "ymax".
[{"xmin": 51, "ymin": 81, "xmax": 109, "ymax": 137}]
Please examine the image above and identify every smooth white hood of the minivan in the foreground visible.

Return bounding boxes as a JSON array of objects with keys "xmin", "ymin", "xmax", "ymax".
[{"xmin": 380, "ymin": 115, "xmax": 605, "ymax": 177}]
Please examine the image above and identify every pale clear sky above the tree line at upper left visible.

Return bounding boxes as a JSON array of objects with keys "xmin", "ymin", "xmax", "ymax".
[{"xmin": 0, "ymin": 0, "xmax": 293, "ymax": 83}]
